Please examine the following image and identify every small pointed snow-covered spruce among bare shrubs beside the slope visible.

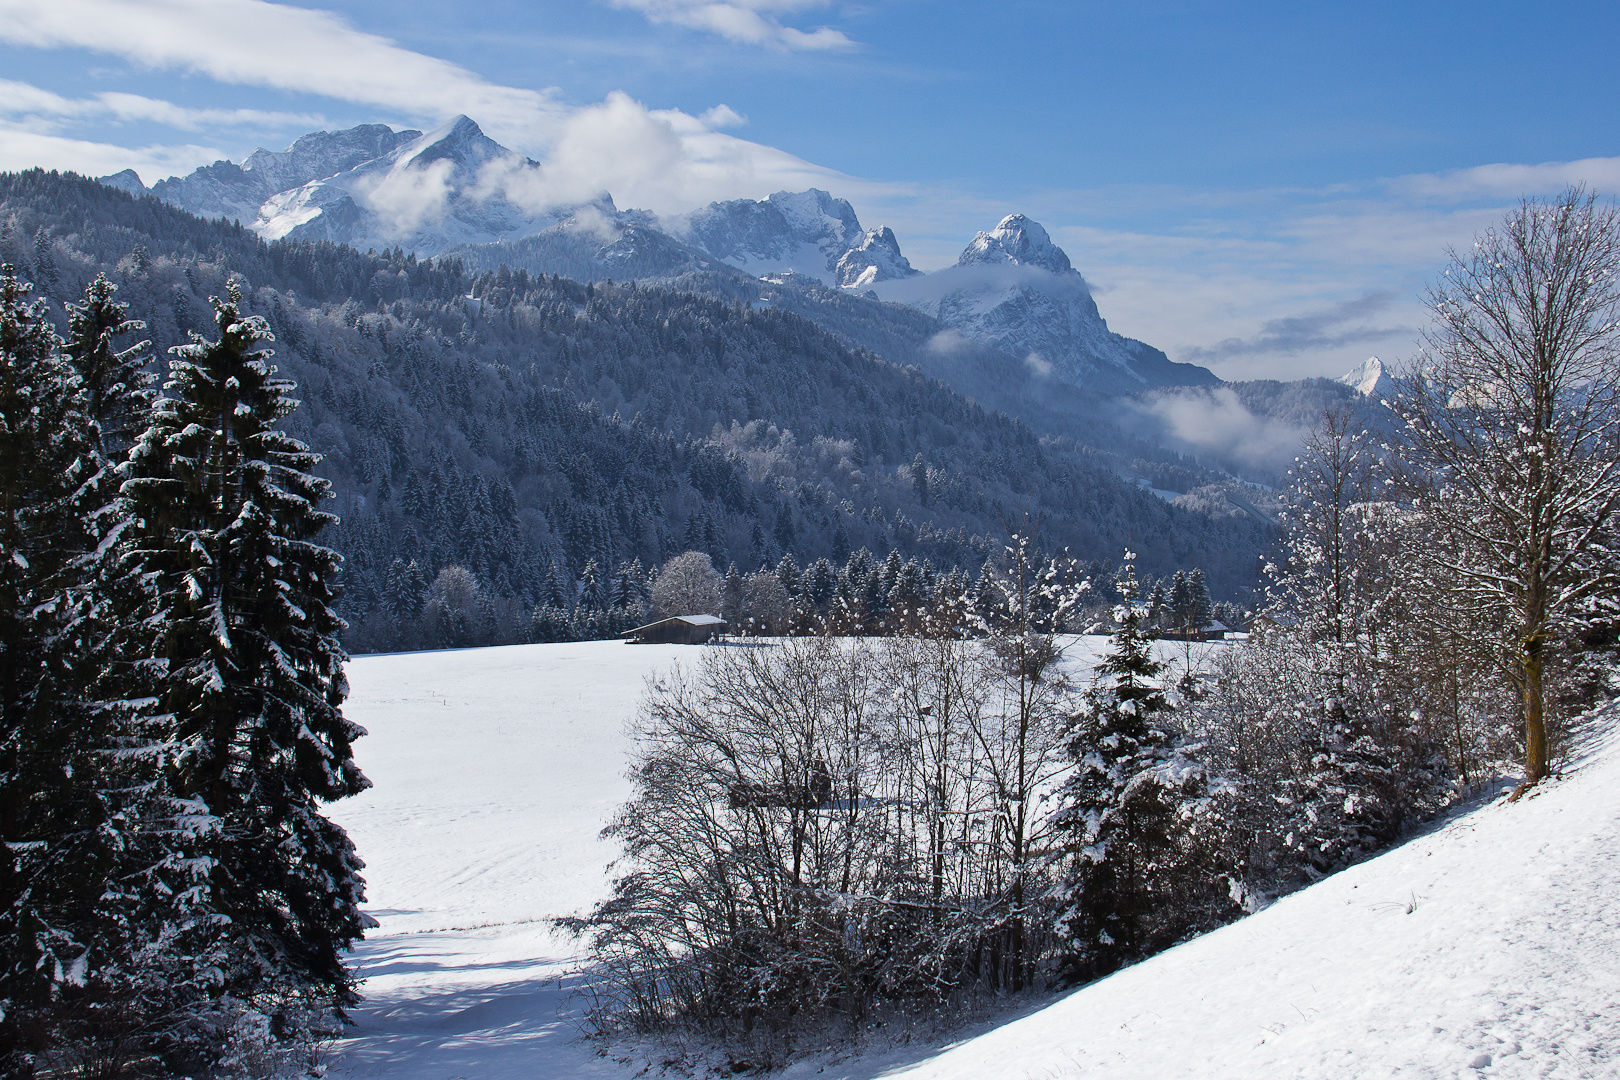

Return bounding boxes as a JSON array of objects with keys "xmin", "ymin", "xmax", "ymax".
[{"xmin": 1053, "ymin": 551, "xmax": 1239, "ymax": 981}]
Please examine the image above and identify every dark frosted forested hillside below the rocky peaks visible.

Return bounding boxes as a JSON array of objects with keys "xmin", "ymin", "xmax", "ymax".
[{"xmin": 0, "ymin": 170, "xmax": 1268, "ymax": 644}]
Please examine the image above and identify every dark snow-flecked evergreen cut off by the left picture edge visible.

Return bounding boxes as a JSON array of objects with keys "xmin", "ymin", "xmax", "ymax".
[{"xmin": 0, "ymin": 266, "xmax": 105, "ymax": 1075}]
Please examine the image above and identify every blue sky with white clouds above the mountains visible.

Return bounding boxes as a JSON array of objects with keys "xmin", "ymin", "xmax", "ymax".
[{"xmin": 0, "ymin": 0, "xmax": 1620, "ymax": 377}]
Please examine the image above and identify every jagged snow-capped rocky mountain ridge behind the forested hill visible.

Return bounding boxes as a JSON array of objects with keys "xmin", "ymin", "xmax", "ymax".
[{"xmin": 104, "ymin": 117, "xmax": 1220, "ymax": 395}]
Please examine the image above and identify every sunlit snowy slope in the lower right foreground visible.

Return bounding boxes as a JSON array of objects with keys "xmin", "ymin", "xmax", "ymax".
[{"xmin": 787, "ymin": 711, "xmax": 1620, "ymax": 1080}]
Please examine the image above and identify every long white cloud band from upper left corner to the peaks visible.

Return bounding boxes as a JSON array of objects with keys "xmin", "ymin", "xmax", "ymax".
[{"xmin": 0, "ymin": 0, "xmax": 875, "ymax": 215}]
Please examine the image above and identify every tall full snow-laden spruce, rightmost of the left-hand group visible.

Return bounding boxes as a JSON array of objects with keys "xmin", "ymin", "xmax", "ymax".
[{"xmin": 123, "ymin": 283, "xmax": 368, "ymax": 1055}]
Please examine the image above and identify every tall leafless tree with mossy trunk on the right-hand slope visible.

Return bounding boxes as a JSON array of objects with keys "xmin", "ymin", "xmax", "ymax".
[{"xmin": 1396, "ymin": 188, "xmax": 1620, "ymax": 792}]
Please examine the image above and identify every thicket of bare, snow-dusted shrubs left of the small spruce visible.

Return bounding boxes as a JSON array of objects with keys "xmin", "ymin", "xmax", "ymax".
[{"xmin": 572, "ymin": 573, "xmax": 1069, "ymax": 1040}]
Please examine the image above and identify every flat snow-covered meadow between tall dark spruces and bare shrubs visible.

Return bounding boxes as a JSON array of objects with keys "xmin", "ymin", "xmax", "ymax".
[{"xmin": 332, "ymin": 641, "xmax": 697, "ymax": 1080}]
